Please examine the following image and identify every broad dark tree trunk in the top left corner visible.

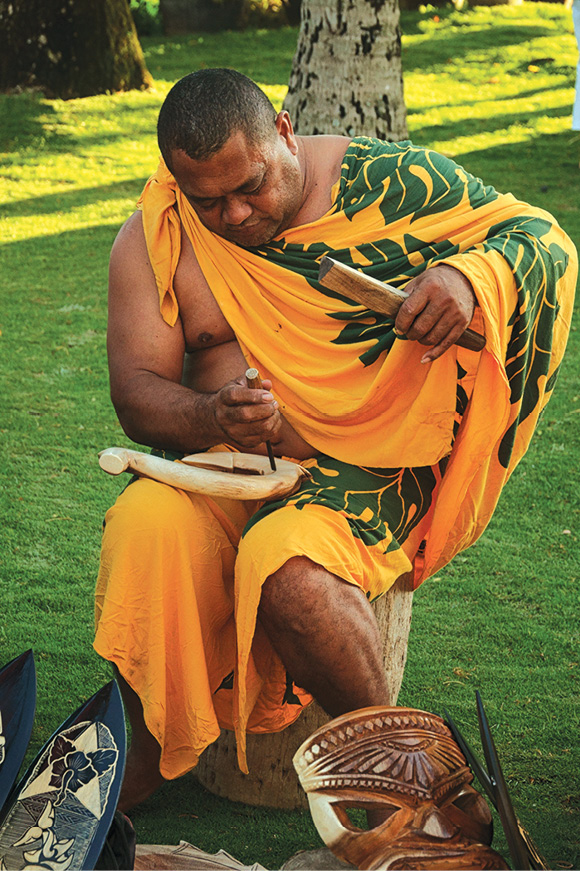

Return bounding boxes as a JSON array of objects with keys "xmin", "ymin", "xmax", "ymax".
[{"xmin": 0, "ymin": 0, "xmax": 152, "ymax": 100}]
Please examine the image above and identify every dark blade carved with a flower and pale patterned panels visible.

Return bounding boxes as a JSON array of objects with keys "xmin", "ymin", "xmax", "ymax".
[{"xmin": 0, "ymin": 681, "xmax": 126, "ymax": 871}]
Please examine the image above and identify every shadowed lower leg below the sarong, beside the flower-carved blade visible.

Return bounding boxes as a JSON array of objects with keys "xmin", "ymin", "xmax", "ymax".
[{"xmin": 115, "ymin": 668, "xmax": 164, "ymax": 812}]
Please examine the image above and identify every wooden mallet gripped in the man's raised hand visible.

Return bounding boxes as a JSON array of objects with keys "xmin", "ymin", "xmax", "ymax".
[{"xmin": 318, "ymin": 257, "xmax": 485, "ymax": 351}]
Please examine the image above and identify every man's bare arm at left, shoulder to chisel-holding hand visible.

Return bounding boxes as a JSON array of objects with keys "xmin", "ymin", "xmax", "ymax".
[{"xmin": 107, "ymin": 212, "xmax": 280, "ymax": 451}]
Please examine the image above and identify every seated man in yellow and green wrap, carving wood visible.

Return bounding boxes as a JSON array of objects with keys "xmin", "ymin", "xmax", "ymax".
[{"xmin": 95, "ymin": 70, "xmax": 577, "ymax": 809}]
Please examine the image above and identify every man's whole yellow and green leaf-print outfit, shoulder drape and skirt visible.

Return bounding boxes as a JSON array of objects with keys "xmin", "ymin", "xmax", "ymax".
[{"xmin": 95, "ymin": 137, "xmax": 577, "ymax": 777}]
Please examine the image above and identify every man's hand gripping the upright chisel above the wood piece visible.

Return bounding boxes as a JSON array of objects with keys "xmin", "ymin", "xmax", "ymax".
[{"xmin": 212, "ymin": 375, "xmax": 282, "ymax": 449}]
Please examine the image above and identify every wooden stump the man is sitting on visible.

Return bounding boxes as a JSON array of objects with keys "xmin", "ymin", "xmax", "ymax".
[{"xmin": 194, "ymin": 575, "xmax": 413, "ymax": 809}]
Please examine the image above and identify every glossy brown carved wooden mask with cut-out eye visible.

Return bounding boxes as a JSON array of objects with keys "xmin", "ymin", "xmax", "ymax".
[{"xmin": 294, "ymin": 707, "xmax": 508, "ymax": 871}]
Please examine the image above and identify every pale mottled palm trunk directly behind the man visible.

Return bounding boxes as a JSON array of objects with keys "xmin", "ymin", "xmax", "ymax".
[{"xmin": 284, "ymin": 0, "xmax": 407, "ymax": 141}]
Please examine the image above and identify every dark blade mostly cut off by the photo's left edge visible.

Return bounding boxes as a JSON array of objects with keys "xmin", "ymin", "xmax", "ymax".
[{"xmin": 0, "ymin": 650, "xmax": 36, "ymax": 818}]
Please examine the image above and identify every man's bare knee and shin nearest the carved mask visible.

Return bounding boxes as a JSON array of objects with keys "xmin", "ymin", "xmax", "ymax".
[{"xmin": 259, "ymin": 557, "xmax": 391, "ymax": 717}]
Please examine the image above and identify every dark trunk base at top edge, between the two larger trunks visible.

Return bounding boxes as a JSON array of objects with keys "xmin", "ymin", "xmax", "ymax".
[{"xmin": 159, "ymin": 0, "xmax": 244, "ymax": 36}]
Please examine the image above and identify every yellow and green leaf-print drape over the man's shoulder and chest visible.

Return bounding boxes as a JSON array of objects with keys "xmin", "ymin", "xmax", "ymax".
[{"xmin": 140, "ymin": 137, "xmax": 577, "ymax": 585}]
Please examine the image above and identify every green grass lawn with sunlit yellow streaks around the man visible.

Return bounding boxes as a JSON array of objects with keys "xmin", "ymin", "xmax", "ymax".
[{"xmin": 0, "ymin": 3, "xmax": 580, "ymax": 868}]
